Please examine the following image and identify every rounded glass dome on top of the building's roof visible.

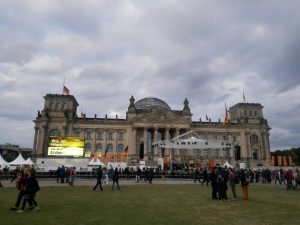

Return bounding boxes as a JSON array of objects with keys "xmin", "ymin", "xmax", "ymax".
[{"xmin": 134, "ymin": 97, "xmax": 171, "ymax": 111}]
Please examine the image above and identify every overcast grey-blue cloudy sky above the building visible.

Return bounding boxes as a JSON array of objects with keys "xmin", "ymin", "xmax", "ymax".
[{"xmin": 0, "ymin": 0, "xmax": 300, "ymax": 150}]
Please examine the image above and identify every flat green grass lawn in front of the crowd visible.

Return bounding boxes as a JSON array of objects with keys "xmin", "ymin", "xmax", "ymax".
[{"xmin": 0, "ymin": 184, "xmax": 300, "ymax": 225}]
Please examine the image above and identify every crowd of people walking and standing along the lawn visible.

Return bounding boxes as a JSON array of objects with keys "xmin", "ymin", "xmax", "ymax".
[{"xmin": 0, "ymin": 163, "xmax": 300, "ymax": 213}]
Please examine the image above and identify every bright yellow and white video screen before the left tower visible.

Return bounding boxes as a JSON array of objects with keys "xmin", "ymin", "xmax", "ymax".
[{"xmin": 48, "ymin": 136, "xmax": 84, "ymax": 157}]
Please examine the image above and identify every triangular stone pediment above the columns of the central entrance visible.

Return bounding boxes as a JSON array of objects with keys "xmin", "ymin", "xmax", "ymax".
[{"xmin": 132, "ymin": 109, "xmax": 190, "ymax": 124}]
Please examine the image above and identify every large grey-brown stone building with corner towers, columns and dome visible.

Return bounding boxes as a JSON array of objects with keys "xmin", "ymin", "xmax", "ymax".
[{"xmin": 33, "ymin": 94, "xmax": 270, "ymax": 167}]
